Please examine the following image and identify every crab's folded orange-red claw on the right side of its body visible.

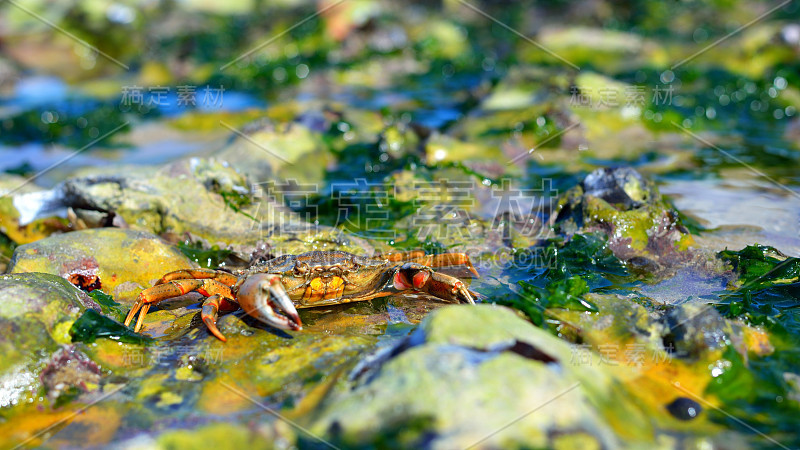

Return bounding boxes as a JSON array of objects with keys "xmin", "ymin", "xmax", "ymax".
[{"xmin": 393, "ymin": 263, "xmax": 475, "ymax": 305}]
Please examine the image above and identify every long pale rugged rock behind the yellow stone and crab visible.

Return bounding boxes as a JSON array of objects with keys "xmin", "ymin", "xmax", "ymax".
[{"xmin": 11, "ymin": 158, "xmax": 371, "ymax": 260}]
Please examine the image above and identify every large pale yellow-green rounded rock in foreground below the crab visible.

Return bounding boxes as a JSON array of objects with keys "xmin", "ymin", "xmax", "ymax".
[{"xmin": 311, "ymin": 306, "xmax": 664, "ymax": 448}]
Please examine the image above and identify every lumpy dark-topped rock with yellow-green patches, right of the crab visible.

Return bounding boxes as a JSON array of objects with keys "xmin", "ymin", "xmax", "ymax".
[{"xmin": 554, "ymin": 167, "xmax": 696, "ymax": 272}]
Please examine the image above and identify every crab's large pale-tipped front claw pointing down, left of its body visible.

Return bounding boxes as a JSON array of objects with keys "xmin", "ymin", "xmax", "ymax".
[{"xmin": 237, "ymin": 273, "xmax": 303, "ymax": 330}]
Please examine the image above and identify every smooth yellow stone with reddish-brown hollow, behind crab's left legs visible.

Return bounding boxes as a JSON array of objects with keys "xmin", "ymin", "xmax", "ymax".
[{"xmin": 8, "ymin": 228, "xmax": 195, "ymax": 302}]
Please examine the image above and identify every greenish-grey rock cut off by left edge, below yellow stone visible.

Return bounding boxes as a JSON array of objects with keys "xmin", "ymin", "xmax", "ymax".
[{"xmin": 0, "ymin": 273, "xmax": 100, "ymax": 407}]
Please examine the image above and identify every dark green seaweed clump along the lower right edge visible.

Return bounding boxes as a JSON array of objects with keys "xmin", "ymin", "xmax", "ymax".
[{"xmin": 706, "ymin": 245, "xmax": 800, "ymax": 447}]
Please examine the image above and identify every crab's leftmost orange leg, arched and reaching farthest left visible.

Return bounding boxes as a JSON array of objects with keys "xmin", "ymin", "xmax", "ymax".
[{"xmin": 125, "ymin": 278, "xmax": 233, "ymax": 333}]
